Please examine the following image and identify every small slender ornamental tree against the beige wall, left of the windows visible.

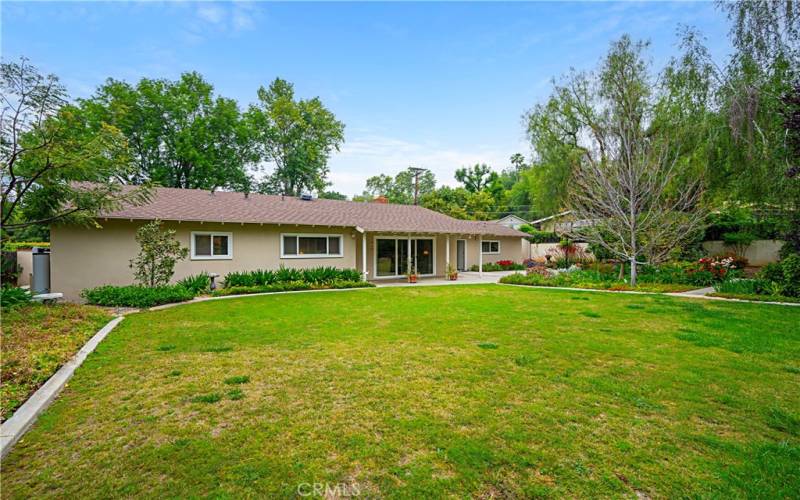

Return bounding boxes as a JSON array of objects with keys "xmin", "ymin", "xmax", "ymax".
[{"xmin": 130, "ymin": 220, "xmax": 189, "ymax": 287}]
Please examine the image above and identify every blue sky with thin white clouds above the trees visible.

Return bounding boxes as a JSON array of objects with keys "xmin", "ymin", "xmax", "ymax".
[{"xmin": 0, "ymin": 1, "xmax": 729, "ymax": 195}]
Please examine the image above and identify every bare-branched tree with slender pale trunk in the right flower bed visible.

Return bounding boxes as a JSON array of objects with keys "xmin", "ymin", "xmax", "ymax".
[{"xmin": 563, "ymin": 36, "xmax": 704, "ymax": 285}]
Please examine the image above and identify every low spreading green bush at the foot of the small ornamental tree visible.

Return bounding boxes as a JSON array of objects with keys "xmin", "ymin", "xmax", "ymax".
[{"xmin": 81, "ymin": 285, "xmax": 194, "ymax": 308}]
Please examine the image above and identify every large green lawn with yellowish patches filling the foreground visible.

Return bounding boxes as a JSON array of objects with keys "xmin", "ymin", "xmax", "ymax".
[{"xmin": 2, "ymin": 285, "xmax": 800, "ymax": 498}]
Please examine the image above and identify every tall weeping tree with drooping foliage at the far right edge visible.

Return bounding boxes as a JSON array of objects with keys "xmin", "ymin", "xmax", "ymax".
[{"xmin": 680, "ymin": 0, "xmax": 800, "ymax": 207}]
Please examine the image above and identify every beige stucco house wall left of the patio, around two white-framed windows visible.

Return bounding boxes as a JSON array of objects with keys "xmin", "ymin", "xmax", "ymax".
[{"xmin": 50, "ymin": 220, "xmax": 360, "ymax": 301}]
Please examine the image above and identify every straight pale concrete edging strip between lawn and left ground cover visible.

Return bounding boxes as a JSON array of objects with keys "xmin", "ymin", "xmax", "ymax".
[{"xmin": 0, "ymin": 316, "xmax": 125, "ymax": 458}]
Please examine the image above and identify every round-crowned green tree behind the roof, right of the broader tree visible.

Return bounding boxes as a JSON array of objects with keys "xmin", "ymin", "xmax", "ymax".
[{"xmin": 247, "ymin": 78, "xmax": 344, "ymax": 196}]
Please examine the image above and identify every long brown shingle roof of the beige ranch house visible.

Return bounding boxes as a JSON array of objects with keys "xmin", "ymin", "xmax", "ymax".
[{"xmin": 99, "ymin": 188, "xmax": 527, "ymax": 237}]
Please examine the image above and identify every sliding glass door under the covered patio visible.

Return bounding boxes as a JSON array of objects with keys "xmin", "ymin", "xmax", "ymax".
[{"xmin": 375, "ymin": 237, "xmax": 434, "ymax": 278}]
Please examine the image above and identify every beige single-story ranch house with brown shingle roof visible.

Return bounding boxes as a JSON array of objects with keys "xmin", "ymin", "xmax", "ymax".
[{"xmin": 50, "ymin": 188, "xmax": 527, "ymax": 300}]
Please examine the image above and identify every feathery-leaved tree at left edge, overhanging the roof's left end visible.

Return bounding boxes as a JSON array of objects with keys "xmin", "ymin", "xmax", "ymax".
[{"xmin": 0, "ymin": 59, "xmax": 148, "ymax": 231}]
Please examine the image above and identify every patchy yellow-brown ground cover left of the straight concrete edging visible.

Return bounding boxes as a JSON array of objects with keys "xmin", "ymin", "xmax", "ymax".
[{"xmin": 0, "ymin": 304, "xmax": 111, "ymax": 421}]
